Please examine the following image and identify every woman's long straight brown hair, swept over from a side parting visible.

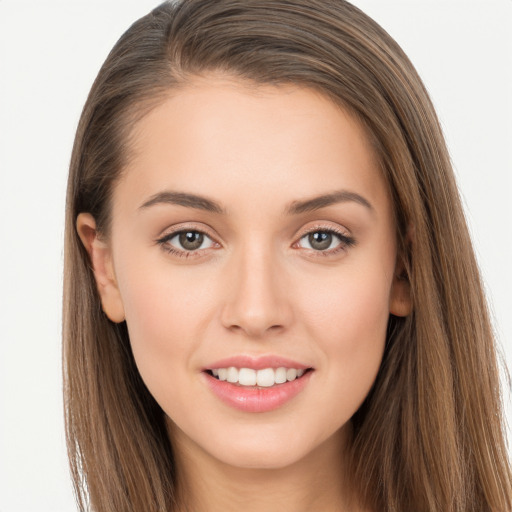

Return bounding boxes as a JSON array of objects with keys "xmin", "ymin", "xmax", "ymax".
[{"xmin": 63, "ymin": 0, "xmax": 512, "ymax": 512}]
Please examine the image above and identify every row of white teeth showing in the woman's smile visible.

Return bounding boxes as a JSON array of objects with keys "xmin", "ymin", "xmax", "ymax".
[{"xmin": 211, "ymin": 366, "xmax": 305, "ymax": 388}]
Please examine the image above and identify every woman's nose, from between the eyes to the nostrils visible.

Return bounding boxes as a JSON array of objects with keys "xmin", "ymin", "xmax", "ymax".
[{"xmin": 222, "ymin": 242, "xmax": 292, "ymax": 339}]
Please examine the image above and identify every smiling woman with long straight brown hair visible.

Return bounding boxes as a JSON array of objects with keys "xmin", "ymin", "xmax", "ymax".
[{"xmin": 64, "ymin": 0, "xmax": 512, "ymax": 512}]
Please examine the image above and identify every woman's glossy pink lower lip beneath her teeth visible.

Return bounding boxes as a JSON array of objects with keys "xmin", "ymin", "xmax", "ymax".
[{"xmin": 204, "ymin": 370, "xmax": 313, "ymax": 412}]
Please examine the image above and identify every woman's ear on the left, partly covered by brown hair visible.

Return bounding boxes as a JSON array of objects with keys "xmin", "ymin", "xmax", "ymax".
[{"xmin": 76, "ymin": 213, "xmax": 125, "ymax": 323}]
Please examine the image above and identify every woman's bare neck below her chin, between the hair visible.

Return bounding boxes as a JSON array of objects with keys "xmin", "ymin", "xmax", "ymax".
[{"xmin": 170, "ymin": 420, "xmax": 361, "ymax": 512}]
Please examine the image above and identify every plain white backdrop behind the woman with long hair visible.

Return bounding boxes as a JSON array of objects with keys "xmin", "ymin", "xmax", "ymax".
[{"xmin": 0, "ymin": 0, "xmax": 512, "ymax": 512}]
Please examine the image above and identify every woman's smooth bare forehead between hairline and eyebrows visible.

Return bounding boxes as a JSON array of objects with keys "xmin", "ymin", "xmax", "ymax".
[{"xmin": 114, "ymin": 76, "xmax": 388, "ymax": 218}]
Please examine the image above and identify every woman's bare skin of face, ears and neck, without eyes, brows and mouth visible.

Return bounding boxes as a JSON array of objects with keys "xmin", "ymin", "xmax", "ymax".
[{"xmin": 77, "ymin": 76, "xmax": 411, "ymax": 512}]
